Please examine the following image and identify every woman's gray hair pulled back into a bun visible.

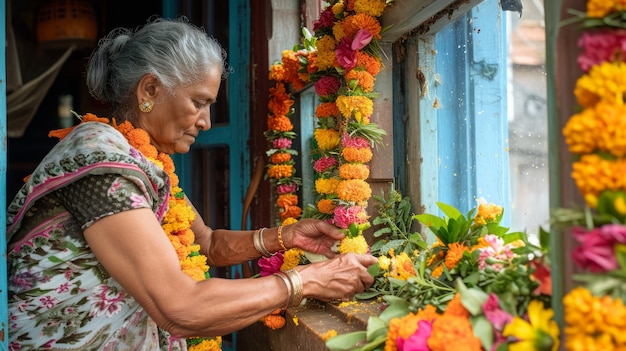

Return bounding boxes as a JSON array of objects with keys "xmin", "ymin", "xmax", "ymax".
[{"xmin": 87, "ymin": 17, "xmax": 229, "ymax": 122}]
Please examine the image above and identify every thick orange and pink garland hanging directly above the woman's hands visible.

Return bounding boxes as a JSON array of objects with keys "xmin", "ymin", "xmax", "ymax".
[{"xmin": 309, "ymin": 0, "xmax": 391, "ymax": 253}]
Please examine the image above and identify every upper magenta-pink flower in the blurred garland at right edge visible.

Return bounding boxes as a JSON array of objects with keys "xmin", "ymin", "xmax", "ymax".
[{"xmin": 578, "ymin": 30, "xmax": 626, "ymax": 72}]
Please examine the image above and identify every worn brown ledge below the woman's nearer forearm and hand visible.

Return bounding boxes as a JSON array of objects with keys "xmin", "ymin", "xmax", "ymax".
[{"xmin": 237, "ymin": 300, "xmax": 381, "ymax": 351}]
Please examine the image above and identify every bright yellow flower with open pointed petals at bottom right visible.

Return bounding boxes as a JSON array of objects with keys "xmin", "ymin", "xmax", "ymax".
[{"xmin": 502, "ymin": 300, "xmax": 559, "ymax": 351}]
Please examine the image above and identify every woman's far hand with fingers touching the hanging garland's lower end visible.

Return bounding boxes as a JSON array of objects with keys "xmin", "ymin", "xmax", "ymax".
[{"xmin": 283, "ymin": 218, "xmax": 344, "ymax": 258}]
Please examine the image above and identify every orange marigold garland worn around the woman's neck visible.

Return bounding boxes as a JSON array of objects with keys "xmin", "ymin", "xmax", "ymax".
[{"xmin": 49, "ymin": 113, "xmax": 222, "ymax": 351}]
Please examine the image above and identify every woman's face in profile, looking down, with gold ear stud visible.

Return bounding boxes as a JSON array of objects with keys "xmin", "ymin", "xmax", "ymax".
[{"xmin": 137, "ymin": 69, "xmax": 222, "ymax": 154}]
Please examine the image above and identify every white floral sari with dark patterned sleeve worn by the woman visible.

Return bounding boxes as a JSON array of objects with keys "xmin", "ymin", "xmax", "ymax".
[{"xmin": 7, "ymin": 122, "xmax": 187, "ymax": 351}]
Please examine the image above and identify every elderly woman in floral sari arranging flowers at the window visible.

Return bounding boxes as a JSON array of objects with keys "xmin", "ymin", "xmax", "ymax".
[{"xmin": 7, "ymin": 19, "xmax": 376, "ymax": 350}]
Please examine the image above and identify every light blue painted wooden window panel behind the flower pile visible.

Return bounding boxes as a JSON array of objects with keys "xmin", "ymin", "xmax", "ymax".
[{"xmin": 432, "ymin": 0, "xmax": 510, "ymax": 225}]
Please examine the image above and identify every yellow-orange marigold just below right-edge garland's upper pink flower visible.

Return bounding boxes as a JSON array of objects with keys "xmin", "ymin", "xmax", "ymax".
[{"xmin": 574, "ymin": 61, "xmax": 626, "ymax": 108}]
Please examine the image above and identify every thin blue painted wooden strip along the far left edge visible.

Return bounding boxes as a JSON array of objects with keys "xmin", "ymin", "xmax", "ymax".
[{"xmin": 0, "ymin": 0, "xmax": 9, "ymax": 351}]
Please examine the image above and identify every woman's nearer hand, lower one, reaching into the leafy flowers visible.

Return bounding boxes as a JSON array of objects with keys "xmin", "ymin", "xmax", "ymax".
[{"xmin": 297, "ymin": 253, "xmax": 377, "ymax": 301}]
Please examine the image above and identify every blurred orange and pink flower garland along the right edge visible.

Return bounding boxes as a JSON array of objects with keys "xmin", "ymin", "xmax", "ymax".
[{"xmin": 554, "ymin": 0, "xmax": 626, "ymax": 351}]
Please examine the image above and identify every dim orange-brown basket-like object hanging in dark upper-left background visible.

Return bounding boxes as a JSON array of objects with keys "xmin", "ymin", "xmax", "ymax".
[{"xmin": 37, "ymin": 0, "xmax": 98, "ymax": 47}]
